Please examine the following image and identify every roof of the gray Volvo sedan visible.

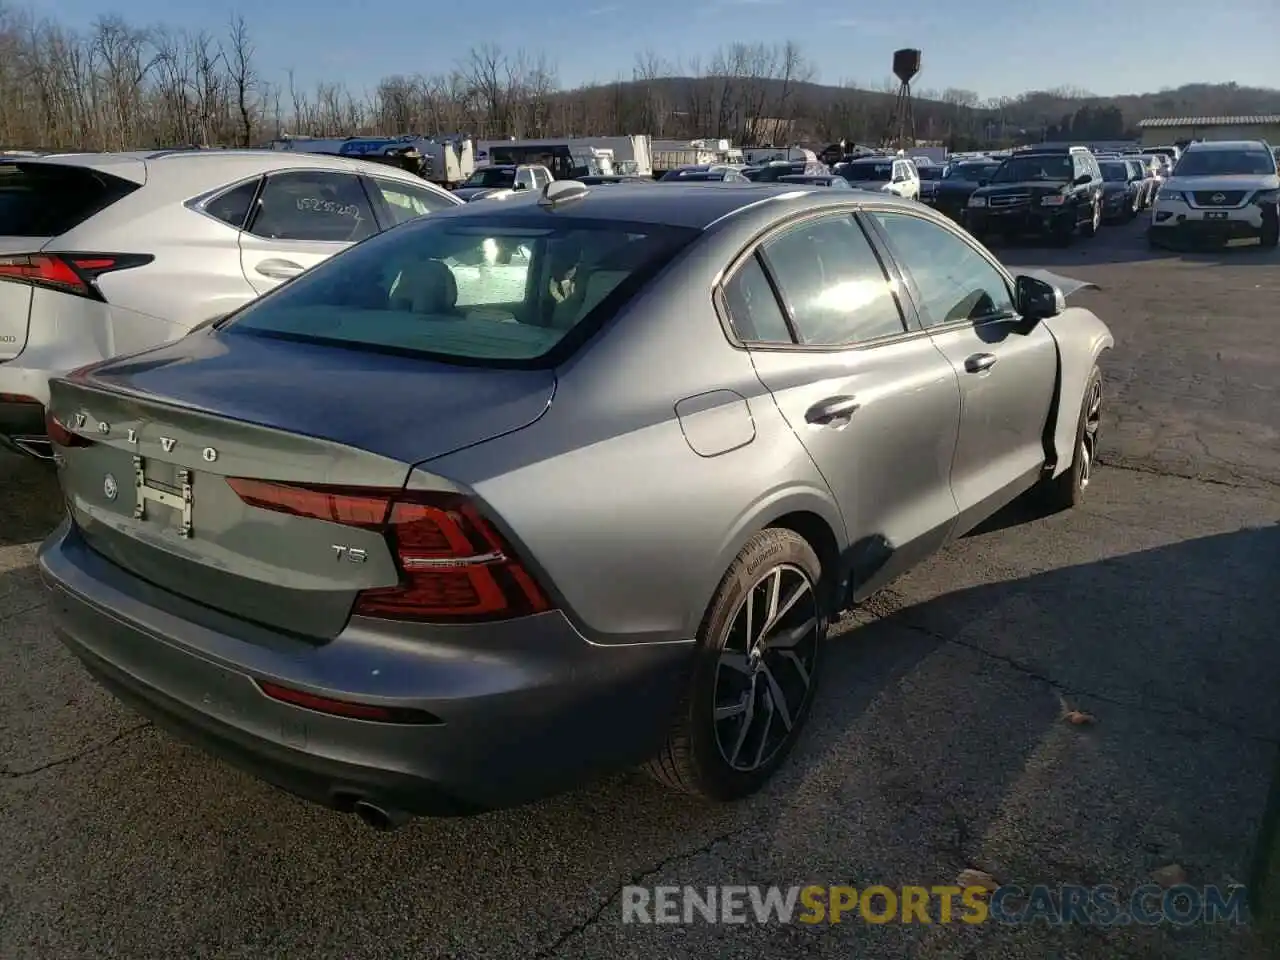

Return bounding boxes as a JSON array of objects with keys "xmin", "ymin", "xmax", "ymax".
[{"xmin": 431, "ymin": 180, "xmax": 920, "ymax": 230}]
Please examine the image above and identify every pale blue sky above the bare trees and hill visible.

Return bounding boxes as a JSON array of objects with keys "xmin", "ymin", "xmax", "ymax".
[{"xmin": 35, "ymin": 0, "xmax": 1280, "ymax": 97}]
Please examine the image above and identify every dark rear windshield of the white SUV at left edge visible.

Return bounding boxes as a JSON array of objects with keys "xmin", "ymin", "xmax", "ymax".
[{"xmin": 0, "ymin": 164, "xmax": 138, "ymax": 237}]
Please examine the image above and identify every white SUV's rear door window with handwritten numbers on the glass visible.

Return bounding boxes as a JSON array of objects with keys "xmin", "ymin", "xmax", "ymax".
[{"xmin": 248, "ymin": 170, "xmax": 378, "ymax": 243}]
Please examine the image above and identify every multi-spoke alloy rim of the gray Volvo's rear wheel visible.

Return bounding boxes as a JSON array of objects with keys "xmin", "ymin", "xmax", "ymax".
[{"xmin": 713, "ymin": 563, "xmax": 820, "ymax": 773}]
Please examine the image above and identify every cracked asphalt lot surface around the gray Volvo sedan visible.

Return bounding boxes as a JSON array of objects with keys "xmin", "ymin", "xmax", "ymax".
[{"xmin": 0, "ymin": 225, "xmax": 1280, "ymax": 960}]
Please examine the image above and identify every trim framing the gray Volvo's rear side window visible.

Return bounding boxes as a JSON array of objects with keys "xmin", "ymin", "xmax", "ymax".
[{"xmin": 712, "ymin": 207, "xmax": 928, "ymax": 353}]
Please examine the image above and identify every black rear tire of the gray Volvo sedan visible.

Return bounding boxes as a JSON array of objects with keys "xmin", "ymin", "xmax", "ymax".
[{"xmin": 646, "ymin": 527, "xmax": 828, "ymax": 801}]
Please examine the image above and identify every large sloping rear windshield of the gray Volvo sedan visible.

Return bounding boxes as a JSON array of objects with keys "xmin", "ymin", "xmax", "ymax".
[{"xmin": 219, "ymin": 211, "xmax": 698, "ymax": 366}]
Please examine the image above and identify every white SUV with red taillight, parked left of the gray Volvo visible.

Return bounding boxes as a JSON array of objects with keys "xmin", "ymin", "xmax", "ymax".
[{"xmin": 0, "ymin": 150, "xmax": 462, "ymax": 457}]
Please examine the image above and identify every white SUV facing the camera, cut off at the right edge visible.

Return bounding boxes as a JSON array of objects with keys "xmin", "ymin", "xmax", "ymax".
[{"xmin": 1147, "ymin": 140, "xmax": 1280, "ymax": 248}]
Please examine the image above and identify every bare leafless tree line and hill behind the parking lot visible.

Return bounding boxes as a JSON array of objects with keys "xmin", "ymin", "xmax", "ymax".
[{"xmin": 0, "ymin": 6, "xmax": 1280, "ymax": 151}]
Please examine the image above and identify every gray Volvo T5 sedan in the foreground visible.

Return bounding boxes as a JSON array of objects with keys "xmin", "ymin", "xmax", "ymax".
[{"xmin": 40, "ymin": 182, "xmax": 1112, "ymax": 828}]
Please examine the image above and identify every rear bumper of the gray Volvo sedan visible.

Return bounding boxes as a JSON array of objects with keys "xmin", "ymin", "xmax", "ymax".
[{"xmin": 40, "ymin": 521, "xmax": 694, "ymax": 815}]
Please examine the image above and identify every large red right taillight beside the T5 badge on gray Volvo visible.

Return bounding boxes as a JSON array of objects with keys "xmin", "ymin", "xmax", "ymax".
[{"xmin": 227, "ymin": 477, "xmax": 550, "ymax": 623}]
